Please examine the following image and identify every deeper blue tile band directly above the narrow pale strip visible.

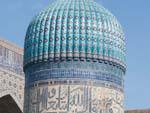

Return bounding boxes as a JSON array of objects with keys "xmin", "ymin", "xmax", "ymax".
[{"xmin": 27, "ymin": 69, "xmax": 124, "ymax": 87}]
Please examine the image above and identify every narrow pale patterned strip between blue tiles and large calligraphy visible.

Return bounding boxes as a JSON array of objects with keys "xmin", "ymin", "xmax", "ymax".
[{"xmin": 25, "ymin": 78, "xmax": 124, "ymax": 93}]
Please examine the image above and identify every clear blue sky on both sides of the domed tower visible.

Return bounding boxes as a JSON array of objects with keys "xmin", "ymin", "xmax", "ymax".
[{"xmin": 0, "ymin": 0, "xmax": 150, "ymax": 109}]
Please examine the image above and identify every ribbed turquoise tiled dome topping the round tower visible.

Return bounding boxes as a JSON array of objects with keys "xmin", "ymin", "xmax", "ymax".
[{"xmin": 24, "ymin": 0, "xmax": 125, "ymax": 67}]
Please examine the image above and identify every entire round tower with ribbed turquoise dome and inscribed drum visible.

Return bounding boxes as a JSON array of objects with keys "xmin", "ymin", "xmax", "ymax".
[{"xmin": 24, "ymin": 0, "xmax": 126, "ymax": 113}]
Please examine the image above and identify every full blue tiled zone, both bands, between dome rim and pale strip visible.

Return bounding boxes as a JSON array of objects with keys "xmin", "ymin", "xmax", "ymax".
[{"xmin": 26, "ymin": 62, "xmax": 124, "ymax": 87}]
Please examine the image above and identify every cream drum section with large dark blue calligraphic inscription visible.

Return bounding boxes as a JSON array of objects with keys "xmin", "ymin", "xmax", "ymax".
[{"xmin": 26, "ymin": 85, "xmax": 124, "ymax": 113}]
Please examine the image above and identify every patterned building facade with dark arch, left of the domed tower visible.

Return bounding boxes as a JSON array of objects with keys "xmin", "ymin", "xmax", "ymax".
[{"xmin": 0, "ymin": 38, "xmax": 24, "ymax": 113}]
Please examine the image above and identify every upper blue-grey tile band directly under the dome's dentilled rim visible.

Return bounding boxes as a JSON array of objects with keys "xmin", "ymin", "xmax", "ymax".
[{"xmin": 24, "ymin": 60, "xmax": 126, "ymax": 76}]
